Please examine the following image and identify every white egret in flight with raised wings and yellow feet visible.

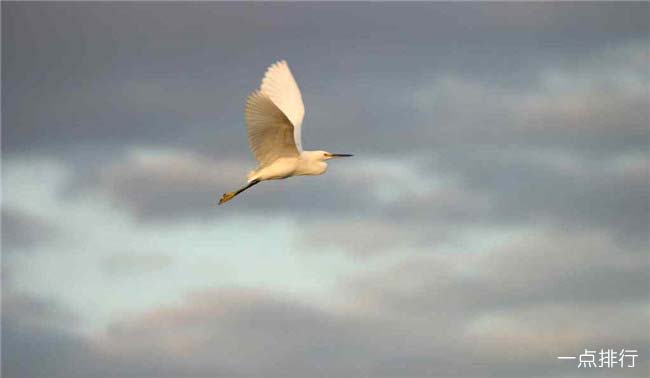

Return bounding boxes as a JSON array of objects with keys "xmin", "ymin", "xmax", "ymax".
[{"xmin": 219, "ymin": 60, "xmax": 352, "ymax": 205}]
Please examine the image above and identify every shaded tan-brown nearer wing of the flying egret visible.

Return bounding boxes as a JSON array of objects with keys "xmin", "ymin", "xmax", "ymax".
[{"xmin": 245, "ymin": 91, "xmax": 300, "ymax": 166}]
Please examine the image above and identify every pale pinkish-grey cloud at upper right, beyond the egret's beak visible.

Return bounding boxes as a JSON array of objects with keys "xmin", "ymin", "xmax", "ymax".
[{"xmin": 412, "ymin": 43, "xmax": 650, "ymax": 159}]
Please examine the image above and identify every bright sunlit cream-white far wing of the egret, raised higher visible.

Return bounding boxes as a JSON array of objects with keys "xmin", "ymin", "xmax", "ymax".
[{"xmin": 260, "ymin": 60, "xmax": 305, "ymax": 151}]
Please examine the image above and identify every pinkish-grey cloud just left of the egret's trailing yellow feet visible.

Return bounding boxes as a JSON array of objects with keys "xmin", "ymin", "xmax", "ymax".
[{"xmin": 95, "ymin": 150, "xmax": 247, "ymax": 219}]
